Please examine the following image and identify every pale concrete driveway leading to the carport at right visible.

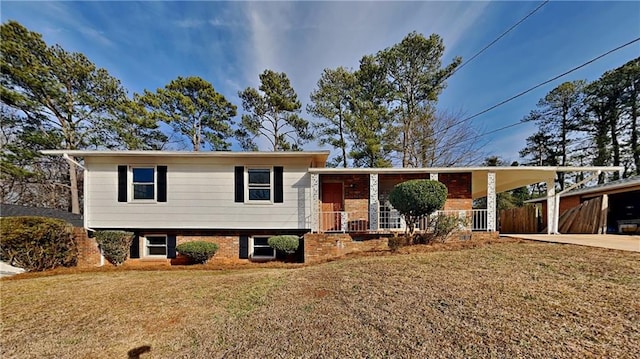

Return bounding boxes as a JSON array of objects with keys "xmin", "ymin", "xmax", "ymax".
[{"xmin": 500, "ymin": 233, "xmax": 640, "ymax": 252}]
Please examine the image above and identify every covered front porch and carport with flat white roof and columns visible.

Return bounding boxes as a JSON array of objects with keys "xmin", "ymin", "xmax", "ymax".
[{"xmin": 309, "ymin": 167, "xmax": 612, "ymax": 233}]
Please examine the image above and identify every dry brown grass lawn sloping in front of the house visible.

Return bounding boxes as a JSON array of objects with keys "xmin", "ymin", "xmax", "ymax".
[{"xmin": 0, "ymin": 242, "xmax": 640, "ymax": 358}]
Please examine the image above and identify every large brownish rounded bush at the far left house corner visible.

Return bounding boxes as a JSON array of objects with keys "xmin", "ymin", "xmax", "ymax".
[{"xmin": 0, "ymin": 217, "xmax": 78, "ymax": 272}]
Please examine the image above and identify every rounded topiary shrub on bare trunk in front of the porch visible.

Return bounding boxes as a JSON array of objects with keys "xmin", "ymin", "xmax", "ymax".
[{"xmin": 389, "ymin": 180, "xmax": 447, "ymax": 234}]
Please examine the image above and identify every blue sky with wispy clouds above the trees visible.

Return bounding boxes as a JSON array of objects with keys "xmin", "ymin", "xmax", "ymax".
[{"xmin": 0, "ymin": 0, "xmax": 640, "ymax": 161}]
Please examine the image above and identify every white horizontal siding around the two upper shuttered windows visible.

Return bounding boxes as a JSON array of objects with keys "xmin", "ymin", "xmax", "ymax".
[{"xmin": 85, "ymin": 157, "xmax": 310, "ymax": 229}]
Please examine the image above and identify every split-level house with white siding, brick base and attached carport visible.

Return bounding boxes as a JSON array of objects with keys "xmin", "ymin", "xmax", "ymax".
[{"xmin": 43, "ymin": 150, "xmax": 617, "ymax": 261}]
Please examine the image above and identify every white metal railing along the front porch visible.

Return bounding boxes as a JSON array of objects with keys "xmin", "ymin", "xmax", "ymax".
[{"xmin": 319, "ymin": 208, "xmax": 487, "ymax": 232}]
